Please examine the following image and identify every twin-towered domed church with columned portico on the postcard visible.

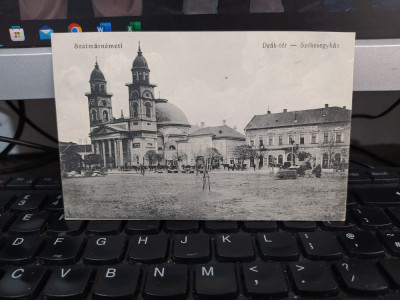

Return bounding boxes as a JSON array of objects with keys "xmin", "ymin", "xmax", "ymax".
[{"xmin": 85, "ymin": 44, "xmax": 191, "ymax": 167}]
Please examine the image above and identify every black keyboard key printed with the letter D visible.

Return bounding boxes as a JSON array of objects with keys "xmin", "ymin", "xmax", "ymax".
[{"xmin": 0, "ymin": 236, "xmax": 43, "ymax": 265}]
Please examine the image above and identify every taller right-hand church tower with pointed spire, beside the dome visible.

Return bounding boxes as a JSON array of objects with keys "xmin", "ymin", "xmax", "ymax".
[{"xmin": 127, "ymin": 43, "xmax": 157, "ymax": 131}]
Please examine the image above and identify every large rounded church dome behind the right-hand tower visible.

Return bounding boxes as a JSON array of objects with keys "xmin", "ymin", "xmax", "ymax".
[{"xmin": 156, "ymin": 100, "xmax": 190, "ymax": 126}]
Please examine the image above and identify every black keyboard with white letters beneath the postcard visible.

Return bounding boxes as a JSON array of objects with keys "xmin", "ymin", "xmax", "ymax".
[{"xmin": 0, "ymin": 169, "xmax": 400, "ymax": 299}]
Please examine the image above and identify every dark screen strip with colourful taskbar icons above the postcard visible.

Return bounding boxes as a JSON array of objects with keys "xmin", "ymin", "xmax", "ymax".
[{"xmin": 0, "ymin": 0, "xmax": 400, "ymax": 48}]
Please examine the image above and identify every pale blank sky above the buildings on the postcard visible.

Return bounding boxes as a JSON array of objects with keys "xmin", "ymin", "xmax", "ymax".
[{"xmin": 52, "ymin": 32, "xmax": 354, "ymax": 143}]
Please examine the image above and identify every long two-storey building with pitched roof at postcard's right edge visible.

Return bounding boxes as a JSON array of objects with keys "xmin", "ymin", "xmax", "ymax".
[{"xmin": 245, "ymin": 104, "xmax": 351, "ymax": 169}]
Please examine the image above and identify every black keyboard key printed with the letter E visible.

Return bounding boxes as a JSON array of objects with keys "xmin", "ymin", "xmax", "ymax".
[{"xmin": 8, "ymin": 212, "xmax": 48, "ymax": 234}]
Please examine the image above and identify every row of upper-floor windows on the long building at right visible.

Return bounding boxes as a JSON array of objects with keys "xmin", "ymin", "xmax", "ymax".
[{"xmin": 250, "ymin": 132, "xmax": 343, "ymax": 147}]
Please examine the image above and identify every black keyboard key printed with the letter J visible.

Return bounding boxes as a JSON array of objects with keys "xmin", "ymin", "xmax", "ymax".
[{"xmin": 173, "ymin": 233, "xmax": 211, "ymax": 263}]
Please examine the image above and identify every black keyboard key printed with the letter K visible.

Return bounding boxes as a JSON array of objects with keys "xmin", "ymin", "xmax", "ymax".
[{"xmin": 216, "ymin": 233, "xmax": 254, "ymax": 261}]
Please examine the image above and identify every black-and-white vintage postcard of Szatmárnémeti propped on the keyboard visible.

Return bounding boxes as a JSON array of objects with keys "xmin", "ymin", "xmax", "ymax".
[{"xmin": 52, "ymin": 31, "xmax": 355, "ymax": 221}]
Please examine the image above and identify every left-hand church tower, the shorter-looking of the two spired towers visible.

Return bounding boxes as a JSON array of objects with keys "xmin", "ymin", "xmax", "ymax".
[{"xmin": 85, "ymin": 59, "xmax": 113, "ymax": 127}]
